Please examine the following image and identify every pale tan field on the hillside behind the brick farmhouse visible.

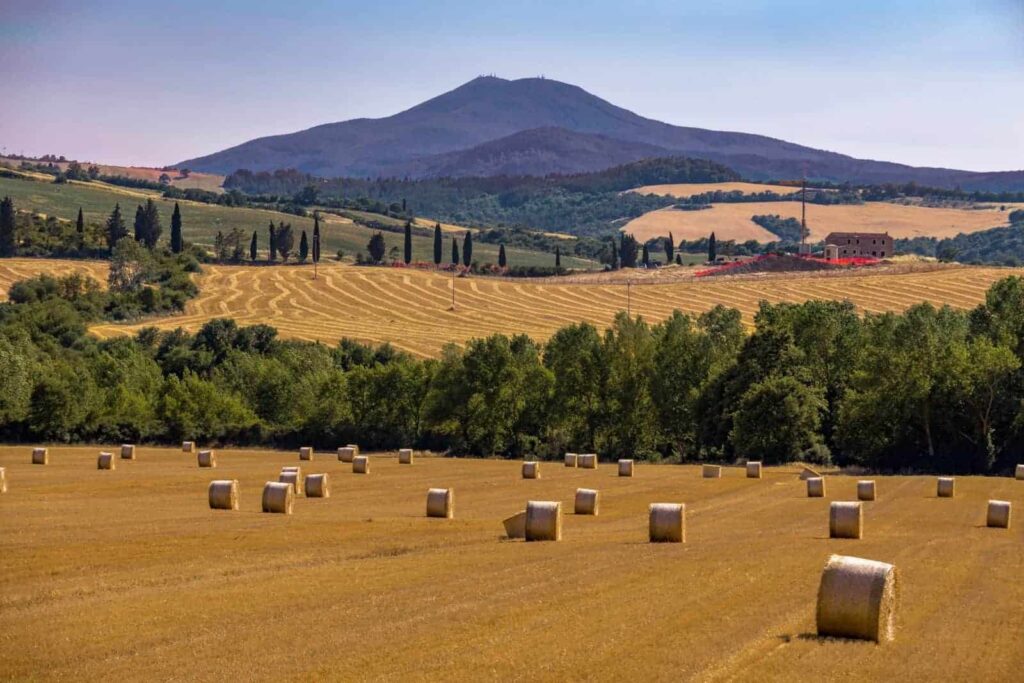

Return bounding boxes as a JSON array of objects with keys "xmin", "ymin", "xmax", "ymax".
[{"xmin": 623, "ymin": 202, "xmax": 1013, "ymax": 242}]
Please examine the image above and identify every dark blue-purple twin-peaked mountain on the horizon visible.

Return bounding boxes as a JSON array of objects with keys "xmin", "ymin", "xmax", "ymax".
[{"xmin": 182, "ymin": 77, "xmax": 1024, "ymax": 190}]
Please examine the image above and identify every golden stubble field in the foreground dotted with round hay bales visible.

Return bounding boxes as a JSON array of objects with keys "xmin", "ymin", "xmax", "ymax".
[{"xmin": 0, "ymin": 446, "xmax": 1024, "ymax": 681}]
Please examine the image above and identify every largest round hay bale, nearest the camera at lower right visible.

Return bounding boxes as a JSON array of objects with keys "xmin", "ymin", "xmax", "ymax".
[{"xmin": 817, "ymin": 555, "xmax": 899, "ymax": 643}]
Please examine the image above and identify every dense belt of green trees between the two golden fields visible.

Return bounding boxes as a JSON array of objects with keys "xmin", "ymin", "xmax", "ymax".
[{"xmin": 0, "ymin": 270, "xmax": 1024, "ymax": 473}]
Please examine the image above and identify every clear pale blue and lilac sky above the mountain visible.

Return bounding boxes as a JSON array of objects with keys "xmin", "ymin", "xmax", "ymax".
[{"xmin": 0, "ymin": 0, "xmax": 1024, "ymax": 171}]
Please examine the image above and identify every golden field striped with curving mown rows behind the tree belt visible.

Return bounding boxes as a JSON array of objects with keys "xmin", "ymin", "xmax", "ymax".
[{"xmin": 86, "ymin": 263, "xmax": 1024, "ymax": 355}]
